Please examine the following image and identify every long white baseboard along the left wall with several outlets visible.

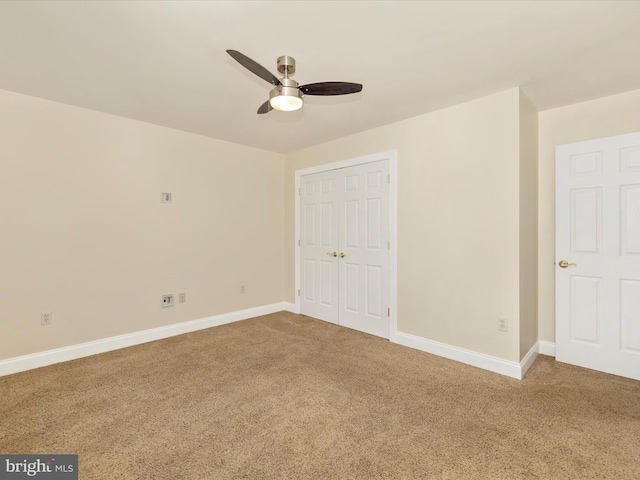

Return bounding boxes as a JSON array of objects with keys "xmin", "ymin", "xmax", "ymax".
[{"xmin": 0, "ymin": 302, "xmax": 286, "ymax": 377}]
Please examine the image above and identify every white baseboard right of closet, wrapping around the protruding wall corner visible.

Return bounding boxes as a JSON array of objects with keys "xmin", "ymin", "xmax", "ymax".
[{"xmin": 392, "ymin": 332, "xmax": 538, "ymax": 380}]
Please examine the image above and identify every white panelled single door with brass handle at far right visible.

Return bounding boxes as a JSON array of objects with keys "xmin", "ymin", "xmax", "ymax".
[{"xmin": 556, "ymin": 133, "xmax": 640, "ymax": 380}]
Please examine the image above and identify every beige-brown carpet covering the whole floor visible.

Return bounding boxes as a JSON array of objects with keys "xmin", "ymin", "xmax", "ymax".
[{"xmin": 0, "ymin": 313, "xmax": 640, "ymax": 480}]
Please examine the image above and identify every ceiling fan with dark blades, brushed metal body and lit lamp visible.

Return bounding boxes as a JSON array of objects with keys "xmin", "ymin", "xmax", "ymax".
[{"xmin": 227, "ymin": 50, "xmax": 362, "ymax": 114}]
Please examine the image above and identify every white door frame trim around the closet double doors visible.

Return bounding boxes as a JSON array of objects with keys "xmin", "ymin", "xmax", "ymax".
[{"xmin": 293, "ymin": 150, "xmax": 398, "ymax": 342}]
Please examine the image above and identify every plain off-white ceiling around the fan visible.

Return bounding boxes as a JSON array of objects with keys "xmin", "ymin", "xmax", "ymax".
[{"xmin": 0, "ymin": 1, "xmax": 640, "ymax": 152}]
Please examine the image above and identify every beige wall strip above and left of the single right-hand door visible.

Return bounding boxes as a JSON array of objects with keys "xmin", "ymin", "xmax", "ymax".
[{"xmin": 538, "ymin": 90, "xmax": 640, "ymax": 342}]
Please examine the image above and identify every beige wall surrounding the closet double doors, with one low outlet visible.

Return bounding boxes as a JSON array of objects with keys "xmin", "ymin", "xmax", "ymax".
[{"xmin": 285, "ymin": 89, "xmax": 520, "ymax": 361}]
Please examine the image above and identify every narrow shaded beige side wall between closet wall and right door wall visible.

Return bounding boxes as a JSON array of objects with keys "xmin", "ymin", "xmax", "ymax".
[{"xmin": 519, "ymin": 92, "xmax": 538, "ymax": 360}]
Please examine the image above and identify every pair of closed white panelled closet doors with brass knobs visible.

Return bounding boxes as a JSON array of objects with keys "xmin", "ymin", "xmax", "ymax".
[{"xmin": 300, "ymin": 160, "xmax": 390, "ymax": 338}]
